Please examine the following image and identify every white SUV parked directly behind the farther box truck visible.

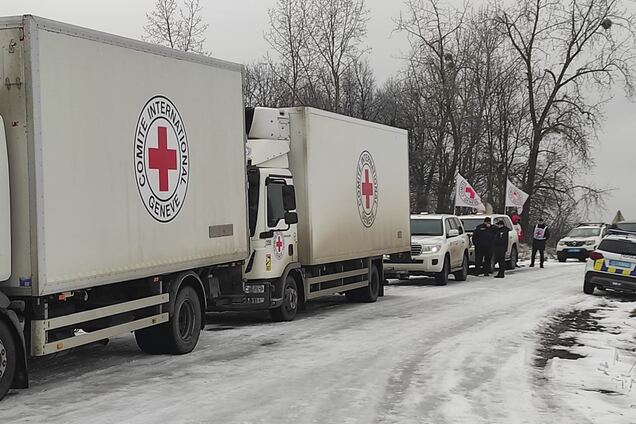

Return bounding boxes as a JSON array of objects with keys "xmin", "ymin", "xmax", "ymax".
[{"xmin": 384, "ymin": 214, "xmax": 470, "ymax": 286}]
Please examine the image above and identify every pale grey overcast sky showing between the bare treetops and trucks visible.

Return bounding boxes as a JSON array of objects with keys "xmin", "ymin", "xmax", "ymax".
[{"xmin": 0, "ymin": 0, "xmax": 636, "ymax": 224}]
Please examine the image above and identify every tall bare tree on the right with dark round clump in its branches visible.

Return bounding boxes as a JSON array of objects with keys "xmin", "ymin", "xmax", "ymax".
[{"xmin": 496, "ymin": 0, "xmax": 636, "ymax": 232}]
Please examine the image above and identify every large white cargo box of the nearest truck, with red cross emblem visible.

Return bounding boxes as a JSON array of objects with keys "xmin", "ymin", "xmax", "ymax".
[{"xmin": 0, "ymin": 16, "xmax": 248, "ymax": 296}]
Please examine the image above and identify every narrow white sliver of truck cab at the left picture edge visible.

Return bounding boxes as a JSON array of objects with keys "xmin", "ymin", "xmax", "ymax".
[{"xmin": 0, "ymin": 117, "xmax": 11, "ymax": 281}]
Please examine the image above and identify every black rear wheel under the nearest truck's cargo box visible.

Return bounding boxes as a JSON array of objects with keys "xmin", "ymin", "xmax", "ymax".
[{"xmin": 167, "ymin": 286, "xmax": 203, "ymax": 355}]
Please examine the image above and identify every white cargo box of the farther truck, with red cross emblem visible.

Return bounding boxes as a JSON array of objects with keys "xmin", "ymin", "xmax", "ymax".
[{"xmin": 287, "ymin": 108, "xmax": 411, "ymax": 265}]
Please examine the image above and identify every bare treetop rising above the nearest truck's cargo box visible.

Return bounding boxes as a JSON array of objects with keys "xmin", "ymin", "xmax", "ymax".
[{"xmin": 142, "ymin": 0, "xmax": 209, "ymax": 55}]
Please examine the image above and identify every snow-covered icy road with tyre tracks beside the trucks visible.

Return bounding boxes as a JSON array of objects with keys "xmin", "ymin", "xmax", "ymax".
[{"xmin": 0, "ymin": 262, "xmax": 628, "ymax": 424}]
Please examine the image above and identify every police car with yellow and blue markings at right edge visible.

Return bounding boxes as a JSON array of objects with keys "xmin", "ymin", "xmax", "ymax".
[{"xmin": 583, "ymin": 234, "xmax": 636, "ymax": 294}]
